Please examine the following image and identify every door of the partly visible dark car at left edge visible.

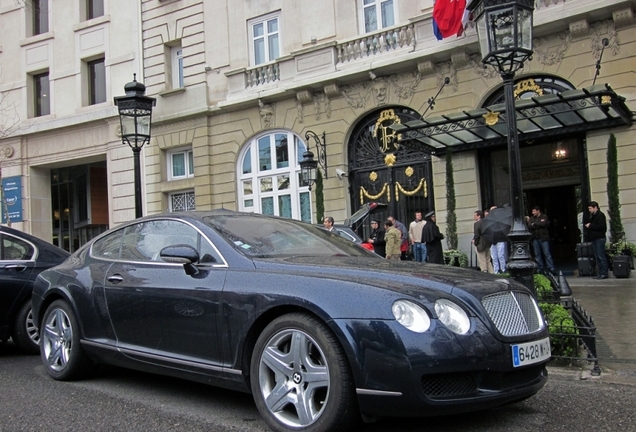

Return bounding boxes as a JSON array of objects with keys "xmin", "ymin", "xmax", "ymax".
[{"xmin": 0, "ymin": 233, "xmax": 37, "ymax": 327}]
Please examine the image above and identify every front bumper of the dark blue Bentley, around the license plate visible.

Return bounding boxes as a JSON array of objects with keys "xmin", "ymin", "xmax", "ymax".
[{"xmin": 337, "ymin": 320, "xmax": 548, "ymax": 417}]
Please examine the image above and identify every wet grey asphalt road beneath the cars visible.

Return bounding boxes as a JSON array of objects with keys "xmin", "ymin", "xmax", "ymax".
[{"xmin": 0, "ymin": 343, "xmax": 636, "ymax": 432}]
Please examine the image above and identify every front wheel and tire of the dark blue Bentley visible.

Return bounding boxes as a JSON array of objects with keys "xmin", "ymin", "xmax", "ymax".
[{"xmin": 250, "ymin": 313, "xmax": 360, "ymax": 432}]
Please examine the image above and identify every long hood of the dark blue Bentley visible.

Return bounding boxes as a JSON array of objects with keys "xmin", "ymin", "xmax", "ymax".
[{"xmin": 254, "ymin": 256, "xmax": 528, "ymax": 303}]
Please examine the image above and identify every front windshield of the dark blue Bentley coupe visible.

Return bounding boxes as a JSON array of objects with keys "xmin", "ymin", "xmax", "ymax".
[{"xmin": 204, "ymin": 214, "xmax": 371, "ymax": 258}]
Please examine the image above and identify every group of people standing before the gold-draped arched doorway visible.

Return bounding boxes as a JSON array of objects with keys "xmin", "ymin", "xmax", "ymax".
[{"xmin": 368, "ymin": 211, "xmax": 444, "ymax": 264}]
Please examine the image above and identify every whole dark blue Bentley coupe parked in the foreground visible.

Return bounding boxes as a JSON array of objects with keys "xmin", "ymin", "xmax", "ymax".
[{"xmin": 33, "ymin": 210, "xmax": 550, "ymax": 432}]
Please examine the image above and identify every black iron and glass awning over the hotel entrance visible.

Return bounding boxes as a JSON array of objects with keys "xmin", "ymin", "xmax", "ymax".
[{"xmin": 391, "ymin": 84, "xmax": 634, "ymax": 156}]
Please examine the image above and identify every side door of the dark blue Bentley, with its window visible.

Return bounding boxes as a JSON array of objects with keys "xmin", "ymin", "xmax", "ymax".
[{"xmin": 104, "ymin": 219, "xmax": 227, "ymax": 364}]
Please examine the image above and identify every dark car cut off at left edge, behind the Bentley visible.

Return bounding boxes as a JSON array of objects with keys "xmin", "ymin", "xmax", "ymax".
[{"xmin": 0, "ymin": 226, "xmax": 69, "ymax": 354}]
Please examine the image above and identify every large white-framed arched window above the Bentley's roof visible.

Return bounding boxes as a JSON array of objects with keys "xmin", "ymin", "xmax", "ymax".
[{"xmin": 237, "ymin": 131, "xmax": 312, "ymax": 222}]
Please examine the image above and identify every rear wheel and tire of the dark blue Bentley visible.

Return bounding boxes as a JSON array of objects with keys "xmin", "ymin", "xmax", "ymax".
[{"xmin": 40, "ymin": 300, "xmax": 95, "ymax": 381}]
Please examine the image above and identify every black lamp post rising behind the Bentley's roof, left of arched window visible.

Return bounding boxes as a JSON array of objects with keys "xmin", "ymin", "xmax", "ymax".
[{"xmin": 114, "ymin": 74, "xmax": 156, "ymax": 218}]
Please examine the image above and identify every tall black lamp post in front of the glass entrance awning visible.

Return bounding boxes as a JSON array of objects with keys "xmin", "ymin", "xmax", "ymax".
[{"xmin": 468, "ymin": 0, "xmax": 536, "ymax": 294}]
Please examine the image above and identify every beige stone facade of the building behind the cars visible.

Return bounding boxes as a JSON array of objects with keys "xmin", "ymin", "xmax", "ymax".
[{"xmin": 0, "ymin": 0, "xmax": 636, "ymax": 251}]
